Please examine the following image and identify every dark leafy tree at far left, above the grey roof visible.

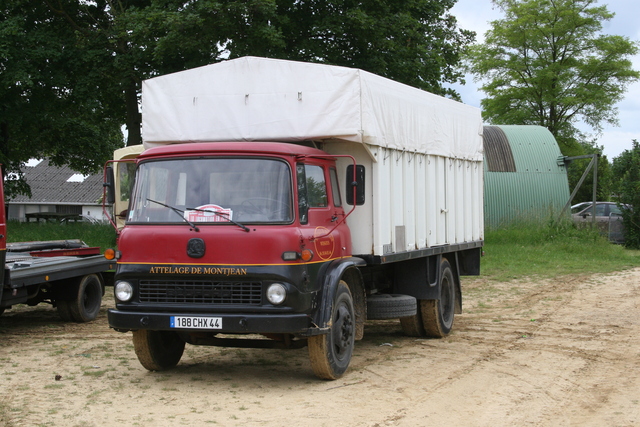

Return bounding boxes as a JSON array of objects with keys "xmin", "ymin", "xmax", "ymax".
[{"xmin": 0, "ymin": 0, "xmax": 122, "ymax": 196}]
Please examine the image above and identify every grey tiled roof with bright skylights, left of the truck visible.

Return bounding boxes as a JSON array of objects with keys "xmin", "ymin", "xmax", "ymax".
[{"xmin": 7, "ymin": 159, "xmax": 102, "ymax": 205}]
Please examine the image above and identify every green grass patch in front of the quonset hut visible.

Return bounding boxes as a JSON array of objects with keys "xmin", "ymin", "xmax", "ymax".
[{"xmin": 481, "ymin": 223, "xmax": 640, "ymax": 281}]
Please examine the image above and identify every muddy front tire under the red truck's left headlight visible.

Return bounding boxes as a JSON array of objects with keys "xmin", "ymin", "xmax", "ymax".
[{"xmin": 133, "ymin": 330, "xmax": 185, "ymax": 371}]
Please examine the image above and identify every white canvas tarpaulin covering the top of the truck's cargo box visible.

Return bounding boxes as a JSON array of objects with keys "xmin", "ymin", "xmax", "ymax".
[{"xmin": 142, "ymin": 57, "xmax": 482, "ymax": 161}]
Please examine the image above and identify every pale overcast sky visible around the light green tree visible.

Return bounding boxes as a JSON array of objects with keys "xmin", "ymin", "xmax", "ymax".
[{"xmin": 451, "ymin": 0, "xmax": 640, "ymax": 161}]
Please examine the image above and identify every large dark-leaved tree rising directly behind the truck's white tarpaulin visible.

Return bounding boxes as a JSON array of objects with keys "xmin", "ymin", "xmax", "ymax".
[{"xmin": 42, "ymin": 0, "xmax": 475, "ymax": 145}]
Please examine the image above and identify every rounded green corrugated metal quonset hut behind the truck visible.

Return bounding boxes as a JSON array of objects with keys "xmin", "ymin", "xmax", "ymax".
[{"xmin": 484, "ymin": 125, "xmax": 569, "ymax": 229}]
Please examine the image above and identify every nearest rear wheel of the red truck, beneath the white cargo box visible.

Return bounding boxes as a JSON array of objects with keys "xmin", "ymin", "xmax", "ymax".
[{"xmin": 420, "ymin": 258, "xmax": 456, "ymax": 338}]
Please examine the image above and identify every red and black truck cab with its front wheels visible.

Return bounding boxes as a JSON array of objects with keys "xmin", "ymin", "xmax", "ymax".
[{"xmin": 108, "ymin": 142, "xmax": 364, "ymax": 378}]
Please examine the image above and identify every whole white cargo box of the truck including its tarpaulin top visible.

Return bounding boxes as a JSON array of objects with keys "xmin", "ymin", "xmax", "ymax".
[{"xmin": 142, "ymin": 57, "xmax": 484, "ymax": 256}]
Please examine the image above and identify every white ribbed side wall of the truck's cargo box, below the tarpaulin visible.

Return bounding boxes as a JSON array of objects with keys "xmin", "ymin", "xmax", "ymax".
[{"xmin": 320, "ymin": 142, "xmax": 484, "ymax": 256}]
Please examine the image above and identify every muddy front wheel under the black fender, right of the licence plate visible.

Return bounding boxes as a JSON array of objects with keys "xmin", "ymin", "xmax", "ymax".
[{"xmin": 308, "ymin": 280, "xmax": 356, "ymax": 380}]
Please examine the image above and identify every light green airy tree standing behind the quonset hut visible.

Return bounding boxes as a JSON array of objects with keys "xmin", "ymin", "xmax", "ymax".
[{"xmin": 469, "ymin": 0, "xmax": 640, "ymax": 155}]
